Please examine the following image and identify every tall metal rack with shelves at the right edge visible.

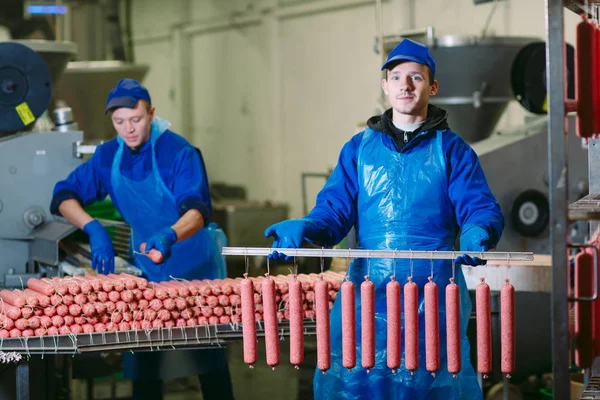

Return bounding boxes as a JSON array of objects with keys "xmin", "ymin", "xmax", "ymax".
[{"xmin": 545, "ymin": 0, "xmax": 600, "ymax": 399}]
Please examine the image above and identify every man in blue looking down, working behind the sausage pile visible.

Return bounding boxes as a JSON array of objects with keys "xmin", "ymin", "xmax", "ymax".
[{"xmin": 51, "ymin": 79, "xmax": 233, "ymax": 400}]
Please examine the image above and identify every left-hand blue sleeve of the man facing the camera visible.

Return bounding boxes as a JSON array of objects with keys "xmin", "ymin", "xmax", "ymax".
[{"xmin": 304, "ymin": 134, "xmax": 362, "ymax": 246}]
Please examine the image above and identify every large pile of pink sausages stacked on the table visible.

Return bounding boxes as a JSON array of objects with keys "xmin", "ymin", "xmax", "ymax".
[{"xmin": 0, "ymin": 273, "xmax": 342, "ymax": 338}]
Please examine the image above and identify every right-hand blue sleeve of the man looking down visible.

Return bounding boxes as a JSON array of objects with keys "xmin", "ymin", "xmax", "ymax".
[{"xmin": 171, "ymin": 146, "xmax": 212, "ymax": 225}]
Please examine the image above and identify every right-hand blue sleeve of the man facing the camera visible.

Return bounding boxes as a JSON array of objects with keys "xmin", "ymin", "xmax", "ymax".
[{"xmin": 444, "ymin": 134, "xmax": 504, "ymax": 246}]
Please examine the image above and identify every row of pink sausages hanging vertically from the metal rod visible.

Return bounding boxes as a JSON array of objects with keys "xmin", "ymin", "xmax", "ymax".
[{"xmin": 240, "ymin": 273, "xmax": 515, "ymax": 377}]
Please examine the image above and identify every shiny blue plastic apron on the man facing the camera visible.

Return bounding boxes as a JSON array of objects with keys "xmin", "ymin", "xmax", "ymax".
[{"xmin": 314, "ymin": 129, "xmax": 482, "ymax": 400}]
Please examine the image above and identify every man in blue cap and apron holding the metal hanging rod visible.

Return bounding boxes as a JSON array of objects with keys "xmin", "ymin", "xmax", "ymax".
[{"xmin": 265, "ymin": 39, "xmax": 504, "ymax": 400}]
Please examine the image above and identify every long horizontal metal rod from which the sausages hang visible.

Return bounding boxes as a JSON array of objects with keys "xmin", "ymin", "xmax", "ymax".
[{"xmin": 221, "ymin": 247, "xmax": 533, "ymax": 262}]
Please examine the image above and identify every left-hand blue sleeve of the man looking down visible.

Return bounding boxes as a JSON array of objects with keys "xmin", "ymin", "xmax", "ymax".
[{"xmin": 50, "ymin": 147, "xmax": 108, "ymax": 215}]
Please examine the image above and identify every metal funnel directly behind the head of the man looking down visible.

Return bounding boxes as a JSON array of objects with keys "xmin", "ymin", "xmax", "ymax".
[{"xmin": 54, "ymin": 61, "xmax": 149, "ymax": 143}]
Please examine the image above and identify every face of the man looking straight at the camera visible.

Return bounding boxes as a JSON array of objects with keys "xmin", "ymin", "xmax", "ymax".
[{"xmin": 381, "ymin": 61, "xmax": 438, "ymax": 116}]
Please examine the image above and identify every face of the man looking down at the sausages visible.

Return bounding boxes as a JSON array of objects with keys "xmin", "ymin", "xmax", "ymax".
[{"xmin": 111, "ymin": 100, "xmax": 154, "ymax": 149}]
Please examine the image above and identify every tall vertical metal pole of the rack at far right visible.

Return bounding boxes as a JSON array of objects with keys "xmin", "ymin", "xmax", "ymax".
[{"xmin": 545, "ymin": 0, "xmax": 570, "ymax": 399}]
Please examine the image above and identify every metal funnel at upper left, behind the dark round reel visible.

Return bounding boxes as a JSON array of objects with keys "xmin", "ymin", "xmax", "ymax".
[{"xmin": 9, "ymin": 40, "xmax": 77, "ymax": 87}]
